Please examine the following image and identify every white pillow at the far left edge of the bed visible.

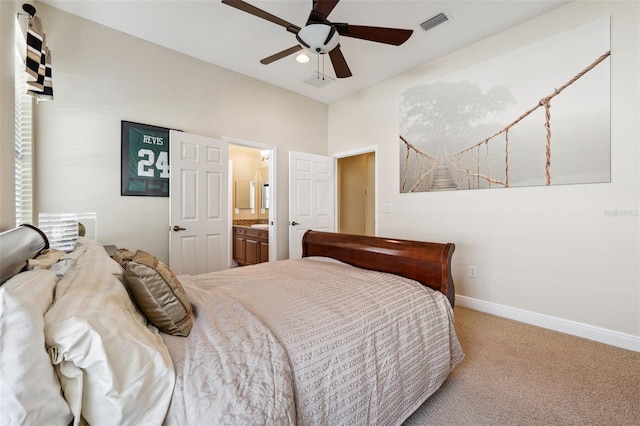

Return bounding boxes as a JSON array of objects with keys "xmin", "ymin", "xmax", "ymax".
[{"xmin": 0, "ymin": 270, "xmax": 72, "ymax": 425}]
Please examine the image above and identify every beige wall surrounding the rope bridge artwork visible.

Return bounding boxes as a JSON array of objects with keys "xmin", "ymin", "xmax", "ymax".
[{"xmin": 329, "ymin": 1, "xmax": 640, "ymax": 342}]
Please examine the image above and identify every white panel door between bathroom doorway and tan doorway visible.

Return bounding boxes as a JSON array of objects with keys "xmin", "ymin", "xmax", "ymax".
[{"xmin": 289, "ymin": 151, "xmax": 335, "ymax": 259}]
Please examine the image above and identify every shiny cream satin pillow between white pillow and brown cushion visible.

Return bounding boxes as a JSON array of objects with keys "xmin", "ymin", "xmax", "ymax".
[{"xmin": 44, "ymin": 242, "xmax": 175, "ymax": 426}]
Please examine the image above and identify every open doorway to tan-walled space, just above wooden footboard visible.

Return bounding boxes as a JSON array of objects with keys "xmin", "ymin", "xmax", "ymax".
[{"xmin": 337, "ymin": 151, "xmax": 376, "ymax": 236}]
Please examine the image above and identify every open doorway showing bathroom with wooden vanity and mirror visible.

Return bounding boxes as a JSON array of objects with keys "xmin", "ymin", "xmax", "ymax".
[{"xmin": 229, "ymin": 140, "xmax": 277, "ymax": 265}]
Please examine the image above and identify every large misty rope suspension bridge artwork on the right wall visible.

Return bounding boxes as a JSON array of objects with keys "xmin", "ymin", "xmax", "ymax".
[{"xmin": 399, "ymin": 17, "xmax": 611, "ymax": 193}]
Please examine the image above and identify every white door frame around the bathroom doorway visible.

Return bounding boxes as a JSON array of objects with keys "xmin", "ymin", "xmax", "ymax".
[{"xmin": 222, "ymin": 136, "xmax": 278, "ymax": 265}]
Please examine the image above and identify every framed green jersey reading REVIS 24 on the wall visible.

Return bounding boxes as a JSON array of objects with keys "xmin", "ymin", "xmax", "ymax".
[{"xmin": 120, "ymin": 120, "xmax": 169, "ymax": 197}]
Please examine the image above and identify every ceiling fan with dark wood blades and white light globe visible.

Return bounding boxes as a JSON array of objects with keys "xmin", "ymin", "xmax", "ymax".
[{"xmin": 222, "ymin": 0, "xmax": 413, "ymax": 78}]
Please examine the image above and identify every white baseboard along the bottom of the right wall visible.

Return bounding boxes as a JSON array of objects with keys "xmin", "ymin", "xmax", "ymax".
[{"xmin": 456, "ymin": 295, "xmax": 640, "ymax": 352}]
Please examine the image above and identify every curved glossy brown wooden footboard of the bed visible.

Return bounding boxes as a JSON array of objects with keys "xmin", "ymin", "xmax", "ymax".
[{"xmin": 302, "ymin": 230, "xmax": 455, "ymax": 306}]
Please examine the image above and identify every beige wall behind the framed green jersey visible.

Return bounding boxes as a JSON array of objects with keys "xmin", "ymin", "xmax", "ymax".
[{"xmin": 20, "ymin": 4, "xmax": 327, "ymax": 261}]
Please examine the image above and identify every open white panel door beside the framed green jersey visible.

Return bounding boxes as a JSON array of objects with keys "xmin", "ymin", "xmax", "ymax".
[{"xmin": 169, "ymin": 130, "xmax": 229, "ymax": 275}]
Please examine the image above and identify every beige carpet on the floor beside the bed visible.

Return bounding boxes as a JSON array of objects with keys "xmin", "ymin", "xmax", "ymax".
[{"xmin": 403, "ymin": 307, "xmax": 640, "ymax": 426}]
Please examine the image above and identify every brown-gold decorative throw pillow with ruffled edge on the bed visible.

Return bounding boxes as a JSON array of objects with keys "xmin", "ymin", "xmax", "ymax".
[{"xmin": 124, "ymin": 250, "xmax": 192, "ymax": 336}]
